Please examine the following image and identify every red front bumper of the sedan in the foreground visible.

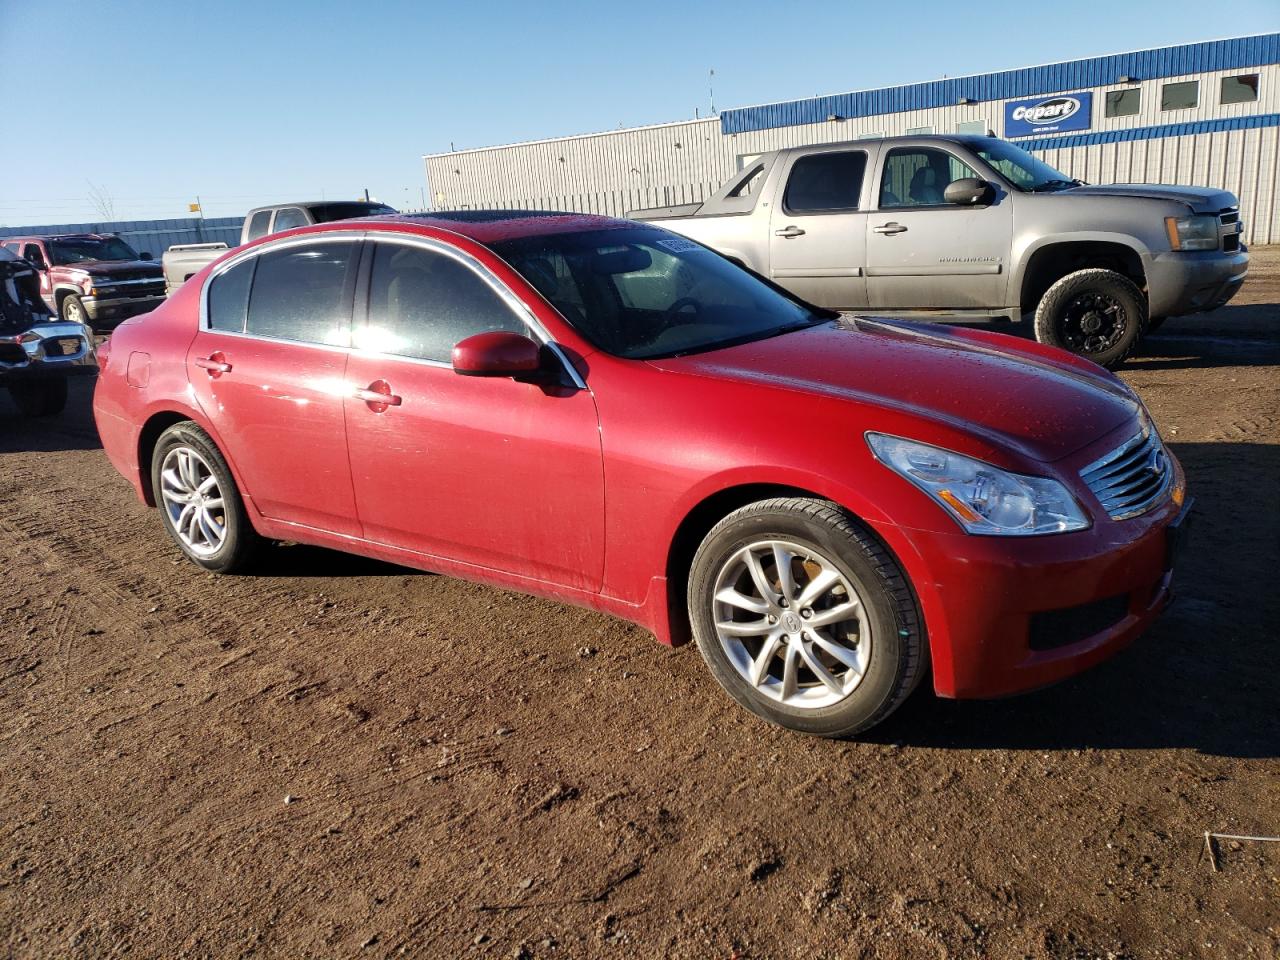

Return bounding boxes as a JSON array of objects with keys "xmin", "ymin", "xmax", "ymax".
[{"xmin": 870, "ymin": 453, "xmax": 1189, "ymax": 698}]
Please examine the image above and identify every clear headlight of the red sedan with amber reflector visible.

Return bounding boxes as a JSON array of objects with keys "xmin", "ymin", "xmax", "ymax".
[{"xmin": 867, "ymin": 433, "xmax": 1089, "ymax": 536}]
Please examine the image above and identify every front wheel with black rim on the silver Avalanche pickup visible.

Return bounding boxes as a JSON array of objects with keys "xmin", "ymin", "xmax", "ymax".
[{"xmin": 1036, "ymin": 268, "xmax": 1147, "ymax": 370}]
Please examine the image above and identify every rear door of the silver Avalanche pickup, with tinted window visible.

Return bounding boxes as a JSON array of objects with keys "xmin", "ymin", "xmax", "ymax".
[{"xmin": 769, "ymin": 147, "xmax": 870, "ymax": 310}]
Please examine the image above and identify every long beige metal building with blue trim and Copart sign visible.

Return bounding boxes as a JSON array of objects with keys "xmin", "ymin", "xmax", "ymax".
[{"xmin": 424, "ymin": 33, "xmax": 1280, "ymax": 243}]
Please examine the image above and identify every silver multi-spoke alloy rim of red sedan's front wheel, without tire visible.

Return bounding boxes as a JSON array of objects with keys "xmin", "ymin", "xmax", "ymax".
[{"xmin": 712, "ymin": 540, "xmax": 872, "ymax": 709}]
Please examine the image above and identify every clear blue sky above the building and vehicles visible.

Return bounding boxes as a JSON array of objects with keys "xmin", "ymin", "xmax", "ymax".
[{"xmin": 0, "ymin": 0, "xmax": 1280, "ymax": 225}]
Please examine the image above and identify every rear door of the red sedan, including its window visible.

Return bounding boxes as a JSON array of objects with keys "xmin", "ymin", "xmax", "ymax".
[{"xmin": 187, "ymin": 234, "xmax": 361, "ymax": 536}]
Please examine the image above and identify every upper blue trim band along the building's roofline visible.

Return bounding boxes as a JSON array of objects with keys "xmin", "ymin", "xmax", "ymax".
[{"xmin": 721, "ymin": 33, "xmax": 1280, "ymax": 133}]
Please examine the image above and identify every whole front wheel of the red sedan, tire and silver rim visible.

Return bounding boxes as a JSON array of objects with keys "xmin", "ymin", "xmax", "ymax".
[{"xmin": 689, "ymin": 498, "xmax": 928, "ymax": 737}]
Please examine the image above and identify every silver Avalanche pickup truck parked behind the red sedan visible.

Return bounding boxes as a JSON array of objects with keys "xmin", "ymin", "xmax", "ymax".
[{"xmin": 628, "ymin": 136, "xmax": 1249, "ymax": 367}]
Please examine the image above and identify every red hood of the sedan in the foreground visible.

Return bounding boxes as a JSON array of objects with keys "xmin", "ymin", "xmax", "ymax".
[{"xmin": 649, "ymin": 317, "xmax": 1142, "ymax": 462}]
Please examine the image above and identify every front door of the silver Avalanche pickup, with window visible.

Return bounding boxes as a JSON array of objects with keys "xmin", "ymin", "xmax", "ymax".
[{"xmin": 867, "ymin": 146, "xmax": 1014, "ymax": 308}]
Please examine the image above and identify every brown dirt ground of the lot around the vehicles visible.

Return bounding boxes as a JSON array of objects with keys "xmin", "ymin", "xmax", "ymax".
[{"xmin": 0, "ymin": 248, "xmax": 1280, "ymax": 960}]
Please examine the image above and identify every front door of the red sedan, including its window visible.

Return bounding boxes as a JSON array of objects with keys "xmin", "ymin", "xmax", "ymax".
[{"xmin": 346, "ymin": 238, "xmax": 604, "ymax": 590}]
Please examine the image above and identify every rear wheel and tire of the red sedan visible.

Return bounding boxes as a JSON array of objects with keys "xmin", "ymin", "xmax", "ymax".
[{"xmin": 151, "ymin": 420, "xmax": 261, "ymax": 573}]
